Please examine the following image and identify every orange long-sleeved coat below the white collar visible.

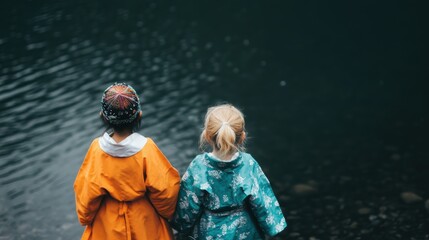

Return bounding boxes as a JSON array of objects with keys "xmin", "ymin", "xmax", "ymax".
[{"xmin": 74, "ymin": 138, "xmax": 180, "ymax": 240}]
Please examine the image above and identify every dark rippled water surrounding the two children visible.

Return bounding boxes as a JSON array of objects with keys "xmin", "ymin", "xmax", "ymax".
[{"xmin": 0, "ymin": 1, "xmax": 429, "ymax": 240}]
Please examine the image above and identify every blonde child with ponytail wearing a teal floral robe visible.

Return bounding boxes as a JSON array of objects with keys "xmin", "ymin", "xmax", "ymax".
[{"xmin": 172, "ymin": 105, "xmax": 287, "ymax": 240}]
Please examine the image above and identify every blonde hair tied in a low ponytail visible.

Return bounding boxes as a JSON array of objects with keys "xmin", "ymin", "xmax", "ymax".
[{"xmin": 200, "ymin": 104, "xmax": 245, "ymax": 158}]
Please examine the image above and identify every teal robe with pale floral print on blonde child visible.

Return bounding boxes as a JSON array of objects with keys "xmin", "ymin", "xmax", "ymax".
[{"xmin": 172, "ymin": 152, "xmax": 287, "ymax": 239}]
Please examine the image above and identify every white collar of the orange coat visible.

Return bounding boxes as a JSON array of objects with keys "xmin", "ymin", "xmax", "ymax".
[{"xmin": 99, "ymin": 132, "xmax": 147, "ymax": 157}]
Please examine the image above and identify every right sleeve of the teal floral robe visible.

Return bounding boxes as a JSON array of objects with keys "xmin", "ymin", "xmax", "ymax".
[{"xmin": 249, "ymin": 161, "xmax": 287, "ymax": 236}]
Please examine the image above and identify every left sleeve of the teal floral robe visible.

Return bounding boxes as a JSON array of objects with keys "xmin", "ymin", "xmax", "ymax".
[{"xmin": 171, "ymin": 162, "xmax": 203, "ymax": 235}]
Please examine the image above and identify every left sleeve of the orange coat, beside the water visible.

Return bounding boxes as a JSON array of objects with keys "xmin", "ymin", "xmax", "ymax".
[{"xmin": 74, "ymin": 142, "xmax": 106, "ymax": 225}]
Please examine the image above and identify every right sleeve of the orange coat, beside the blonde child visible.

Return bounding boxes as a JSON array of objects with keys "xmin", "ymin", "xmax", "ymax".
[{"xmin": 143, "ymin": 139, "xmax": 180, "ymax": 219}]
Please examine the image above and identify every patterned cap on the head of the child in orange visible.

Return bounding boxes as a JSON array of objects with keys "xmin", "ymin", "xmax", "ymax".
[{"xmin": 101, "ymin": 83, "xmax": 140, "ymax": 125}]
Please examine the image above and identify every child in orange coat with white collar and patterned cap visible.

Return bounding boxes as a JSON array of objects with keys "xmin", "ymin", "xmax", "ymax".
[{"xmin": 74, "ymin": 83, "xmax": 180, "ymax": 240}]
